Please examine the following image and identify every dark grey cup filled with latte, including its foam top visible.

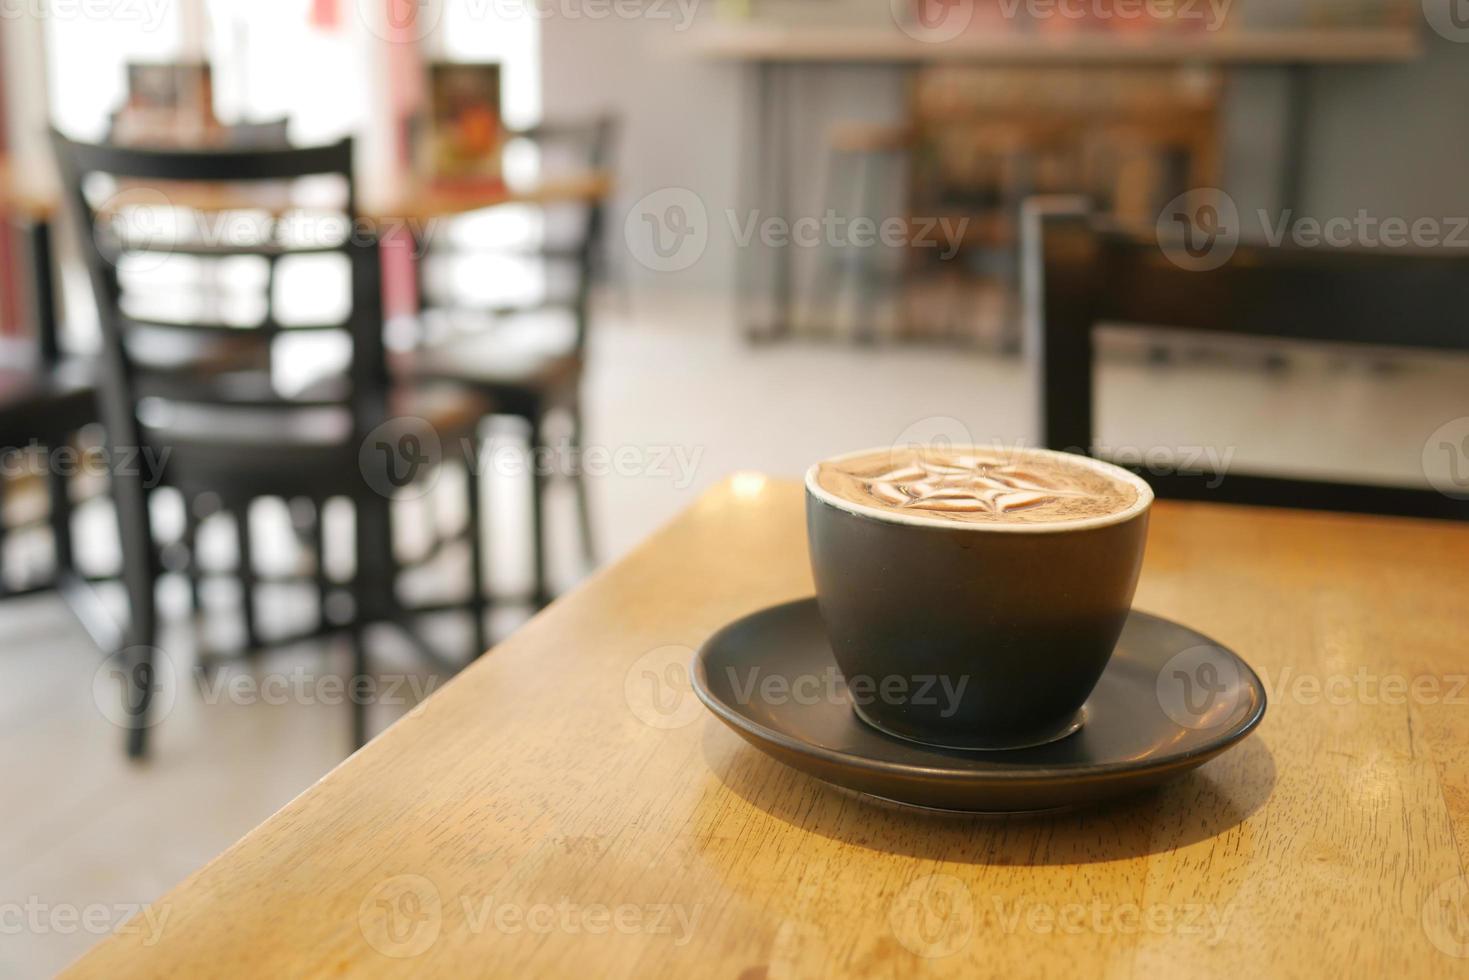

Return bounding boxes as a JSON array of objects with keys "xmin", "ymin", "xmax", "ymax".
[{"xmin": 805, "ymin": 447, "xmax": 1153, "ymax": 749}]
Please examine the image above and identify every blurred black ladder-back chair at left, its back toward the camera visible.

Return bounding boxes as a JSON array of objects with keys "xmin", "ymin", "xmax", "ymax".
[{"xmin": 53, "ymin": 134, "xmax": 486, "ymax": 757}]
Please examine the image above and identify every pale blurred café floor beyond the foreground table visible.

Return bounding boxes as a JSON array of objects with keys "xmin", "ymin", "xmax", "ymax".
[{"xmin": 0, "ymin": 287, "xmax": 1469, "ymax": 977}]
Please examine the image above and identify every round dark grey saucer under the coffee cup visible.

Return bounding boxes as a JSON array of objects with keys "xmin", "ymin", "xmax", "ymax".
[{"xmin": 692, "ymin": 598, "xmax": 1265, "ymax": 813}]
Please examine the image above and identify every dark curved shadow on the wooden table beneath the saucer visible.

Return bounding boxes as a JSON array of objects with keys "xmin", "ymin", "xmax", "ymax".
[{"xmin": 704, "ymin": 724, "xmax": 1275, "ymax": 865}]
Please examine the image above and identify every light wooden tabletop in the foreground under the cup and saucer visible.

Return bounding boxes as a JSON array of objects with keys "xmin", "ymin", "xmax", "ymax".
[{"xmin": 73, "ymin": 475, "xmax": 1469, "ymax": 980}]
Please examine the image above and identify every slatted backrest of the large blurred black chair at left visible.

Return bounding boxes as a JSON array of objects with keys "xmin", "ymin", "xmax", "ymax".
[{"xmin": 53, "ymin": 134, "xmax": 388, "ymax": 438}]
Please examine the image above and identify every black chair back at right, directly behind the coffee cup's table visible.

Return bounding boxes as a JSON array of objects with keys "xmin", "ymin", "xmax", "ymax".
[{"xmin": 1022, "ymin": 198, "xmax": 1469, "ymax": 520}]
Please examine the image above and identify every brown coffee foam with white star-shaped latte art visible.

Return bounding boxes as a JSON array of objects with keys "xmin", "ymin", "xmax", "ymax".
[{"xmin": 808, "ymin": 447, "xmax": 1152, "ymax": 530}]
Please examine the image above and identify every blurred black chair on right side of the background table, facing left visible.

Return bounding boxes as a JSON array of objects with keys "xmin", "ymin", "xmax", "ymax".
[{"xmin": 404, "ymin": 116, "xmax": 617, "ymax": 607}]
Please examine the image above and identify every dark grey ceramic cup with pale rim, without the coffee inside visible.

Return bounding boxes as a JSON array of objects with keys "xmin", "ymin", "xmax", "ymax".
[{"xmin": 806, "ymin": 450, "xmax": 1153, "ymax": 749}]
